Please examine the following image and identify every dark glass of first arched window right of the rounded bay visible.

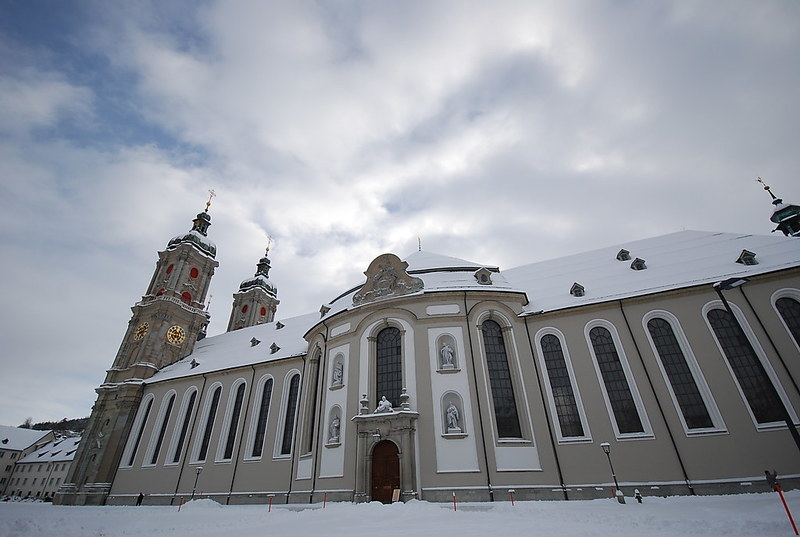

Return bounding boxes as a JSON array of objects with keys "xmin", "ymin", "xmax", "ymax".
[{"xmin": 539, "ymin": 334, "xmax": 585, "ymax": 438}]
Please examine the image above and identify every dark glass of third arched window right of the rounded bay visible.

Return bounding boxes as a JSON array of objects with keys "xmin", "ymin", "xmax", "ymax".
[{"xmin": 647, "ymin": 317, "xmax": 714, "ymax": 429}]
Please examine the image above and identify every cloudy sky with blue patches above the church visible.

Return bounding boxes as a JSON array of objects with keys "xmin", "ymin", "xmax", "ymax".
[{"xmin": 0, "ymin": 0, "xmax": 800, "ymax": 425}]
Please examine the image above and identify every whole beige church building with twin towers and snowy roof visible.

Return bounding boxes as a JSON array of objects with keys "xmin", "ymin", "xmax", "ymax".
[{"xmin": 56, "ymin": 195, "xmax": 800, "ymax": 504}]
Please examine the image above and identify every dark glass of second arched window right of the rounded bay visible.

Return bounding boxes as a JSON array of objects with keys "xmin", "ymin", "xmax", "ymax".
[{"xmin": 589, "ymin": 326, "xmax": 645, "ymax": 434}]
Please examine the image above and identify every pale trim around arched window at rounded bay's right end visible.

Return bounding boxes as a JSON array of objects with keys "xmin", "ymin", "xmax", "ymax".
[{"xmin": 475, "ymin": 309, "xmax": 535, "ymax": 446}]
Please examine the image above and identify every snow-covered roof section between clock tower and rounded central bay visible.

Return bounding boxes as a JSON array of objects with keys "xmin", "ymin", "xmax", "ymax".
[{"xmin": 146, "ymin": 313, "xmax": 319, "ymax": 384}]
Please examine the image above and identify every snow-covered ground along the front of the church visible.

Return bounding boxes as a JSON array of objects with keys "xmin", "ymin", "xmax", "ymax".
[{"xmin": 0, "ymin": 491, "xmax": 800, "ymax": 537}]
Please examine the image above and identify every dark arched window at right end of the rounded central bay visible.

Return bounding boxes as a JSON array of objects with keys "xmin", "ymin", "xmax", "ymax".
[{"xmin": 481, "ymin": 319, "xmax": 522, "ymax": 438}]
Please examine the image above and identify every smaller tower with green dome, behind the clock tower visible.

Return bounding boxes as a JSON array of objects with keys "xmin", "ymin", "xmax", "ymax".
[{"xmin": 228, "ymin": 246, "xmax": 280, "ymax": 332}]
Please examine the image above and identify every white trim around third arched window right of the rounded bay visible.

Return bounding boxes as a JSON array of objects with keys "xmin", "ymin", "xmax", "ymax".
[{"xmin": 642, "ymin": 310, "xmax": 728, "ymax": 436}]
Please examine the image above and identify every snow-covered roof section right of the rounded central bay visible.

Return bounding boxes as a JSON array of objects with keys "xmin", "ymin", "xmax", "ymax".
[{"xmin": 502, "ymin": 231, "xmax": 800, "ymax": 312}]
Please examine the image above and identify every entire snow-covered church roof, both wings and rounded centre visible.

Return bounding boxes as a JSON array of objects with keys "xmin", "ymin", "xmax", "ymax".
[{"xmin": 147, "ymin": 231, "xmax": 800, "ymax": 384}]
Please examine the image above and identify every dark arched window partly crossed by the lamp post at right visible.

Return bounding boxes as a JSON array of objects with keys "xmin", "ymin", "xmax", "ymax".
[{"xmin": 706, "ymin": 309, "xmax": 785, "ymax": 424}]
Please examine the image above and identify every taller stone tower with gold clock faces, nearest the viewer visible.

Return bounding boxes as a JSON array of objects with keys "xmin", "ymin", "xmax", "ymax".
[{"xmin": 55, "ymin": 196, "xmax": 219, "ymax": 505}]
